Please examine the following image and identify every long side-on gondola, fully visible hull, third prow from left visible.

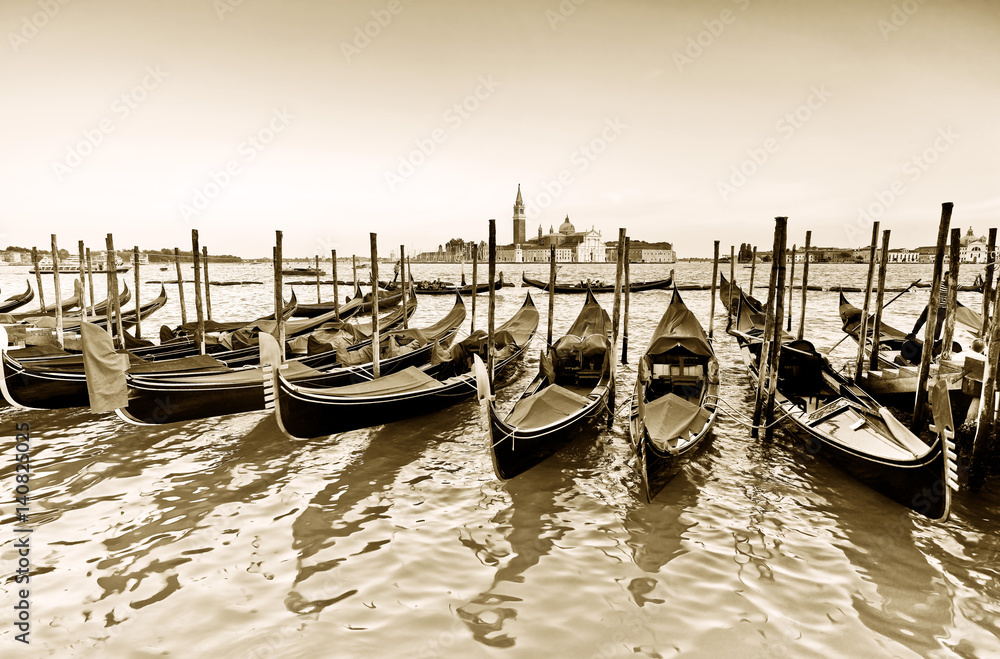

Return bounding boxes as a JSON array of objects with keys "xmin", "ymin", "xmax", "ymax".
[{"xmin": 262, "ymin": 295, "xmax": 538, "ymax": 438}]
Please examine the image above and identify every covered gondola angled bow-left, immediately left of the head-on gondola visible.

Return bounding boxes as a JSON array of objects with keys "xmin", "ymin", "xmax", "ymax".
[{"xmin": 480, "ymin": 291, "xmax": 615, "ymax": 480}]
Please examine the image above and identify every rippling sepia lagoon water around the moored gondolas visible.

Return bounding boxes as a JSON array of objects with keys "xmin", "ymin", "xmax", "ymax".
[{"xmin": 0, "ymin": 263, "xmax": 1000, "ymax": 659}]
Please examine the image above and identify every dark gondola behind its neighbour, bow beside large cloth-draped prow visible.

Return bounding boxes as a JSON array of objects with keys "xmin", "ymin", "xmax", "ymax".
[{"xmin": 117, "ymin": 296, "xmax": 466, "ymax": 424}]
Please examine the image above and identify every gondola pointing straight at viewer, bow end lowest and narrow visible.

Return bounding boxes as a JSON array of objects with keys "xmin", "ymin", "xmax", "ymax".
[{"xmin": 629, "ymin": 289, "xmax": 719, "ymax": 501}]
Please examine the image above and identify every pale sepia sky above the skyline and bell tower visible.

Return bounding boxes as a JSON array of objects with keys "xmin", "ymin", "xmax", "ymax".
[{"xmin": 0, "ymin": 0, "xmax": 1000, "ymax": 258}]
